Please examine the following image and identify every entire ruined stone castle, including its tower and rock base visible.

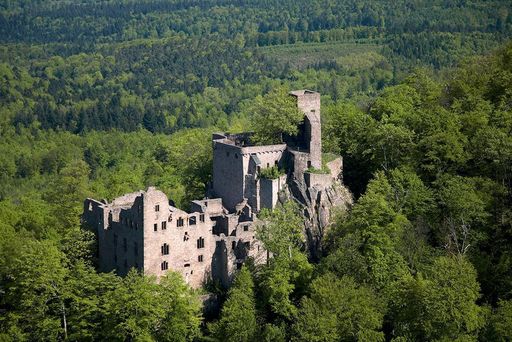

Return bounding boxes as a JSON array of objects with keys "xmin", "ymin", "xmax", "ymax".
[{"xmin": 82, "ymin": 90, "xmax": 351, "ymax": 287}]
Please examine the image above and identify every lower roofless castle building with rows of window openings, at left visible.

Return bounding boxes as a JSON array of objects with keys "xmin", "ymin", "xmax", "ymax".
[{"xmin": 83, "ymin": 187, "xmax": 266, "ymax": 287}]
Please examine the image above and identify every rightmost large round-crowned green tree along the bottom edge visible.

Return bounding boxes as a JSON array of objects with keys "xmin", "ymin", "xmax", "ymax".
[{"xmin": 392, "ymin": 257, "xmax": 484, "ymax": 340}]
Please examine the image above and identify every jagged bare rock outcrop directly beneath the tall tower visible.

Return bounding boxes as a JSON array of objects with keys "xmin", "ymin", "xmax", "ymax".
[{"xmin": 279, "ymin": 158, "xmax": 353, "ymax": 260}]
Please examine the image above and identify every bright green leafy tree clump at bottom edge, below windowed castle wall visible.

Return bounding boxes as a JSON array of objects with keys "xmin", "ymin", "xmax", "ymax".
[{"xmin": 102, "ymin": 270, "xmax": 201, "ymax": 341}]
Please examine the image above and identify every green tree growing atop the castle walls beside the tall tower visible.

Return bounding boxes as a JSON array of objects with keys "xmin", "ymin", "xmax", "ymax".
[{"xmin": 251, "ymin": 87, "xmax": 304, "ymax": 145}]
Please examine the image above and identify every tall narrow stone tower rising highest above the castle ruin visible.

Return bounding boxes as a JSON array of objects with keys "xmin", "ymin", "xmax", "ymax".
[{"xmin": 290, "ymin": 90, "xmax": 322, "ymax": 169}]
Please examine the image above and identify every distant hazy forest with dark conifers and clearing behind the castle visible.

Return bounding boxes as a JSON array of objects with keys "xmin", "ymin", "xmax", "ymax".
[{"xmin": 0, "ymin": 0, "xmax": 512, "ymax": 132}]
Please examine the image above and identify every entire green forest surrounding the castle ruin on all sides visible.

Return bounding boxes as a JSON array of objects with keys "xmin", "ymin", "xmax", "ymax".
[{"xmin": 0, "ymin": 0, "xmax": 512, "ymax": 342}]
